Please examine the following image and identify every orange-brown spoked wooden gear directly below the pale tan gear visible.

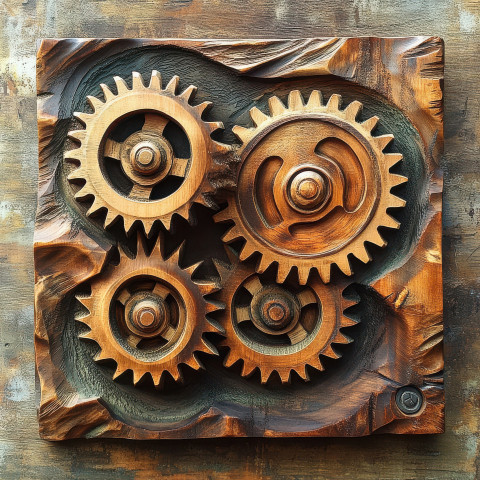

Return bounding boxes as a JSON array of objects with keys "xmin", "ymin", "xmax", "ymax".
[{"xmin": 77, "ymin": 236, "xmax": 219, "ymax": 386}]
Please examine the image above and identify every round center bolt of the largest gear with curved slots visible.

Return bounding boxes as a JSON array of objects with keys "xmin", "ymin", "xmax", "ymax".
[{"xmin": 286, "ymin": 168, "xmax": 331, "ymax": 213}]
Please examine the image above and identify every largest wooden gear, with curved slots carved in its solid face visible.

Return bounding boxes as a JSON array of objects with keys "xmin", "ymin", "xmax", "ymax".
[{"xmin": 215, "ymin": 90, "xmax": 407, "ymax": 284}]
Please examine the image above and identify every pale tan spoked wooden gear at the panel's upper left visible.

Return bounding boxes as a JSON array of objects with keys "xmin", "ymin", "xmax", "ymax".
[{"xmin": 65, "ymin": 71, "xmax": 230, "ymax": 235}]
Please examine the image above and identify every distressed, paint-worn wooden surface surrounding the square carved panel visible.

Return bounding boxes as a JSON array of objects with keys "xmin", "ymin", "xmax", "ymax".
[{"xmin": 0, "ymin": 0, "xmax": 480, "ymax": 480}]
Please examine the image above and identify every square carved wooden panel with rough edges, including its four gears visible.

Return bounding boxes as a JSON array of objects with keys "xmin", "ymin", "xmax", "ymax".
[{"xmin": 35, "ymin": 37, "xmax": 444, "ymax": 440}]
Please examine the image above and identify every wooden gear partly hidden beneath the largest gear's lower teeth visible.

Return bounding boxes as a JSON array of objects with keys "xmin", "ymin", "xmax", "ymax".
[{"xmin": 215, "ymin": 247, "xmax": 357, "ymax": 383}]
